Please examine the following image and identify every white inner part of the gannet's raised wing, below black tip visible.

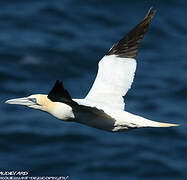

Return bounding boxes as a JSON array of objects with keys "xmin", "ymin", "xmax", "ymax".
[{"xmin": 86, "ymin": 55, "xmax": 136, "ymax": 109}]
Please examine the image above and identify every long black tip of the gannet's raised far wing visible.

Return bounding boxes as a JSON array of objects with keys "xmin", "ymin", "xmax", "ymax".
[{"xmin": 107, "ymin": 7, "xmax": 156, "ymax": 59}]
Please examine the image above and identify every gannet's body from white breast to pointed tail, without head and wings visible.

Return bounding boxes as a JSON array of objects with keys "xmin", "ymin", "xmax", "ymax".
[{"xmin": 53, "ymin": 99, "xmax": 176, "ymax": 132}]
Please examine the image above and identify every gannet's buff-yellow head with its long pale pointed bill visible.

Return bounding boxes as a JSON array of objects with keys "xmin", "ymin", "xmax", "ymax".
[{"xmin": 5, "ymin": 94, "xmax": 52, "ymax": 111}]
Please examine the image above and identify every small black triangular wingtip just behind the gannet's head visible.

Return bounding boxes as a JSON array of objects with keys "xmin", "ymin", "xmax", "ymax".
[{"xmin": 47, "ymin": 80, "xmax": 72, "ymax": 102}]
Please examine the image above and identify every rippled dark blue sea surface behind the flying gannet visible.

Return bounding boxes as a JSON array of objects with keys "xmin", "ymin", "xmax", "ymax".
[{"xmin": 0, "ymin": 0, "xmax": 187, "ymax": 180}]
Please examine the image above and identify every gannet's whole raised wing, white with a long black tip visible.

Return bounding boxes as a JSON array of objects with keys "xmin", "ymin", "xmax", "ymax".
[{"xmin": 86, "ymin": 8, "xmax": 155, "ymax": 109}]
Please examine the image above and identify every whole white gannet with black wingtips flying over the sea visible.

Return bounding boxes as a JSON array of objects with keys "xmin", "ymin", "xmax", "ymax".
[{"xmin": 5, "ymin": 8, "xmax": 178, "ymax": 132}]
